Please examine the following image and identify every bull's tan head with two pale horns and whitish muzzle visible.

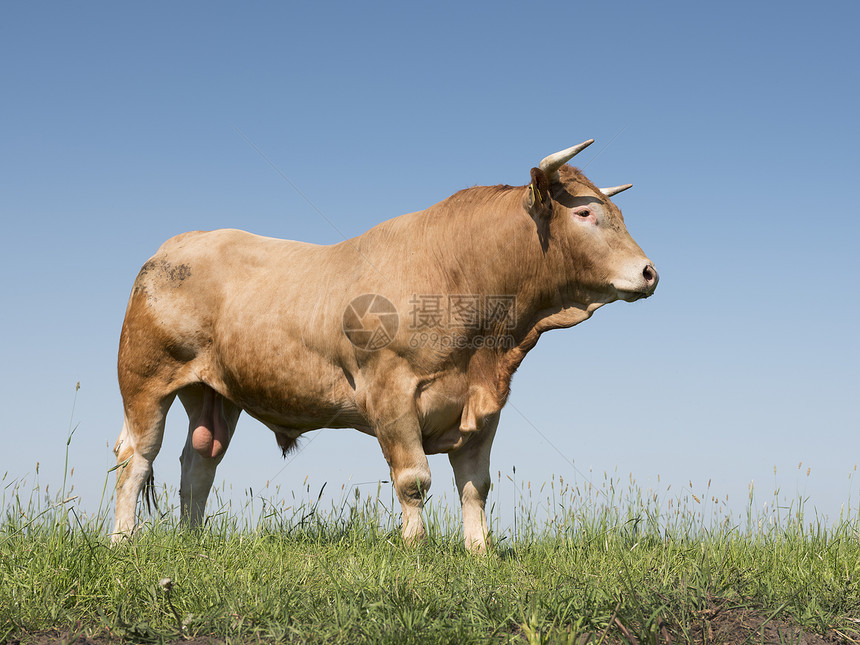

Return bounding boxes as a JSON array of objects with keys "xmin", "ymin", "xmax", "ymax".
[{"xmin": 525, "ymin": 139, "xmax": 659, "ymax": 304}]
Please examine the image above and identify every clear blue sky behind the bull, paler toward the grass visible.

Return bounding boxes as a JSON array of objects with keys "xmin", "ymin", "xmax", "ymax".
[{"xmin": 0, "ymin": 1, "xmax": 860, "ymax": 519}]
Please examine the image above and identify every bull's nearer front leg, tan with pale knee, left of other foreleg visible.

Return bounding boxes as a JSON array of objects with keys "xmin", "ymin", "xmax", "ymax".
[{"xmin": 368, "ymin": 378, "xmax": 430, "ymax": 545}]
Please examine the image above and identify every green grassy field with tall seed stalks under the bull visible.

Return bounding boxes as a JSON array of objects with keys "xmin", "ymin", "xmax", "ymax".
[{"xmin": 0, "ymin": 462, "xmax": 860, "ymax": 644}]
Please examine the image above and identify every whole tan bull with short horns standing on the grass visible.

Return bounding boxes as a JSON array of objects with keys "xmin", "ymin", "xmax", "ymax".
[{"xmin": 109, "ymin": 141, "xmax": 658, "ymax": 551}]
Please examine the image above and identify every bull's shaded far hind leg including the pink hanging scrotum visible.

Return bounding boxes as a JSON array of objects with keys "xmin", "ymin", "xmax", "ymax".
[{"xmin": 179, "ymin": 384, "xmax": 240, "ymax": 526}]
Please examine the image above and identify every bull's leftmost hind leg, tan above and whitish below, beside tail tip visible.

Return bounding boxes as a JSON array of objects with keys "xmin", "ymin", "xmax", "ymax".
[{"xmin": 111, "ymin": 394, "xmax": 173, "ymax": 542}]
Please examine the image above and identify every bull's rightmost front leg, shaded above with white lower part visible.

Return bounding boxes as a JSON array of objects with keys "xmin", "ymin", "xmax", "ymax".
[{"xmin": 448, "ymin": 413, "xmax": 499, "ymax": 553}]
